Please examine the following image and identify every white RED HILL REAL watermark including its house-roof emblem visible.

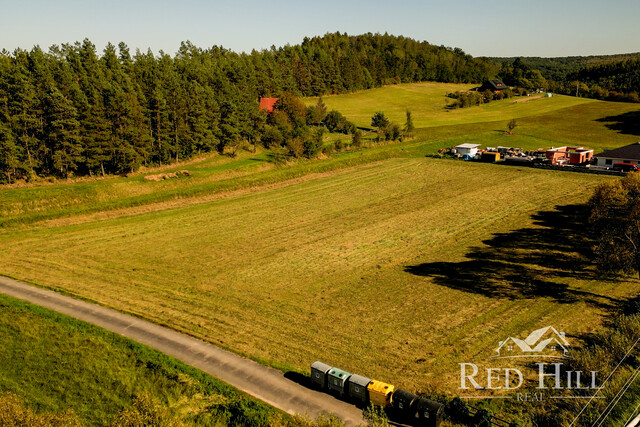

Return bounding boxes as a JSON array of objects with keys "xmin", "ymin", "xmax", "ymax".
[{"xmin": 459, "ymin": 326, "xmax": 600, "ymax": 401}]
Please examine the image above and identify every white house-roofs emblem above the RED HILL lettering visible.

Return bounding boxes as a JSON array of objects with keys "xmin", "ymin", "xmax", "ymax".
[{"xmin": 492, "ymin": 326, "xmax": 569, "ymax": 359}]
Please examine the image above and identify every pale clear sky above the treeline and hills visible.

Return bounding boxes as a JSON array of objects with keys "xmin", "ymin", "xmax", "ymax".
[{"xmin": 0, "ymin": 0, "xmax": 640, "ymax": 57}]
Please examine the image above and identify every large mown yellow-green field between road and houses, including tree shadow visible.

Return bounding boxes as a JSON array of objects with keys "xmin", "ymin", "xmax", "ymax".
[{"xmin": 0, "ymin": 158, "xmax": 640, "ymax": 391}]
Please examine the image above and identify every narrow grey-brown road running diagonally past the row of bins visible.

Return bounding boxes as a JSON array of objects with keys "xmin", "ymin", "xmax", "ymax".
[{"xmin": 0, "ymin": 276, "xmax": 363, "ymax": 426}]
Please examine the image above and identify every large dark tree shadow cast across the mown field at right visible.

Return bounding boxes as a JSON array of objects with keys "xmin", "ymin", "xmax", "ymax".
[{"xmin": 405, "ymin": 205, "xmax": 618, "ymax": 308}]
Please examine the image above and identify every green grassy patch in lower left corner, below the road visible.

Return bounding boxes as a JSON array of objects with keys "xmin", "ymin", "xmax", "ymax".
[{"xmin": 0, "ymin": 295, "xmax": 281, "ymax": 425}]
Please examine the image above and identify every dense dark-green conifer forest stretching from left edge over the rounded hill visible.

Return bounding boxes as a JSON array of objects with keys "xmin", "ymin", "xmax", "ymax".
[{"xmin": 0, "ymin": 33, "xmax": 497, "ymax": 181}]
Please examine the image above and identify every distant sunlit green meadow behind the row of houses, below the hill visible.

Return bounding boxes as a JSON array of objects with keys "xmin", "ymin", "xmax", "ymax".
[{"xmin": 306, "ymin": 83, "xmax": 640, "ymax": 153}]
